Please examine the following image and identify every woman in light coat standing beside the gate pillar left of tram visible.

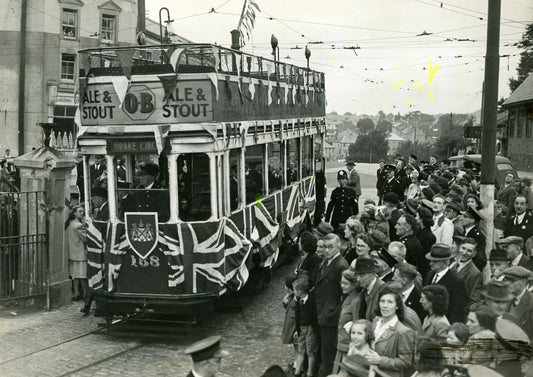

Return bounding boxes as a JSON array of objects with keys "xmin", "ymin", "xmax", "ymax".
[{"xmin": 65, "ymin": 206, "xmax": 90, "ymax": 314}]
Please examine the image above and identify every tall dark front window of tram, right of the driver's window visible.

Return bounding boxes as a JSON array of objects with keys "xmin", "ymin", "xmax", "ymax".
[{"xmin": 177, "ymin": 153, "xmax": 210, "ymax": 221}]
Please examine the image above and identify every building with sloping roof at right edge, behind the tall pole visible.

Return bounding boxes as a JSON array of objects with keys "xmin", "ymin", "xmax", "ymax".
[{"xmin": 503, "ymin": 73, "xmax": 533, "ymax": 171}]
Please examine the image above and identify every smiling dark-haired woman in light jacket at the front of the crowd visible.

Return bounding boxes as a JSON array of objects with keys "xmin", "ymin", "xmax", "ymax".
[{"xmin": 367, "ymin": 286, "xmax": 415, "ymax": 377}]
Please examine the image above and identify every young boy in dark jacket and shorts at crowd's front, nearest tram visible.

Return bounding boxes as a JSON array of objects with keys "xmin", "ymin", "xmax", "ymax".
[{"xmin": 293, "ymin": 279, "xmax": 318, "ymax": 377}]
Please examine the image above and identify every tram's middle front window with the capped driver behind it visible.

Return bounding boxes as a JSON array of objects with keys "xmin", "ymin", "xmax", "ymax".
[{"xmin": 114, "ymin": 154, "xmax": 170, "ymax": 222}]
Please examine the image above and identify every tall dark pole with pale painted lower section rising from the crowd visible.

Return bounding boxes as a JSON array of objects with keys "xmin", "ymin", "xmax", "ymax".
[{"xmin": 480, "ymin": 0, "xmax": 501, "ymax": 275}]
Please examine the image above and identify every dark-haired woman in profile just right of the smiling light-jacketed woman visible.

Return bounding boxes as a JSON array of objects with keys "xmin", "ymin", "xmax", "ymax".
[{"xmin": 420, "ymin": 284, "xmax": 450, "ymax": 343}]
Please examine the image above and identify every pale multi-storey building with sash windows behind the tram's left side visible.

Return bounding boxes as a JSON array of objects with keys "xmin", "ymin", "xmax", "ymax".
[{"xmin": 0, "ymin": 0, "xmax": 187, "ymax": 155}]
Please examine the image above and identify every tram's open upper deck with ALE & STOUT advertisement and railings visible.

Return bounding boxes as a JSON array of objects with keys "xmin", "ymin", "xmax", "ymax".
[{"xmin": 79, "ymin": 44, "xmax": 326, "ymax": 126}]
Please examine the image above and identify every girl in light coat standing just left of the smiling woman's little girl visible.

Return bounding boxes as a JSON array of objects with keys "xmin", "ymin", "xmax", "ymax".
[{"xmin": 333, "ymin": 269, "xmax": 361, "ymax": 374}]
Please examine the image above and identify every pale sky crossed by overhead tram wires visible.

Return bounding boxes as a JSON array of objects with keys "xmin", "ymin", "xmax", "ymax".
[{"xmin": 146, "ymin": 0, "xmax": 533, "ymax": 115}]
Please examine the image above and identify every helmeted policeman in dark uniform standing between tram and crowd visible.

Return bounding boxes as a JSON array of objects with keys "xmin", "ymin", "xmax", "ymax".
[{"xmin": 326, "ymin": 170, "xmax": 359, "ymax": 230}]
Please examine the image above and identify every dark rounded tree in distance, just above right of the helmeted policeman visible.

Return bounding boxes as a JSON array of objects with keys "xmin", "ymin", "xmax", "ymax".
[{"xmin": 348, "ymin": 130, "xmax": 389, "ymax": 162}]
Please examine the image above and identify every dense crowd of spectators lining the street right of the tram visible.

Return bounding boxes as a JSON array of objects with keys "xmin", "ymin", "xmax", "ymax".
[{"xmin": 282, "ymin": 155, "xmax": 533, "ymax": 377}]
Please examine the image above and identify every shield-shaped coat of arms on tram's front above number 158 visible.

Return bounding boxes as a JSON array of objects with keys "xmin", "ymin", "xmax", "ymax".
[{"xmin": 124, "ymin": 212, "xmax": 159, "ymax": 259}]
